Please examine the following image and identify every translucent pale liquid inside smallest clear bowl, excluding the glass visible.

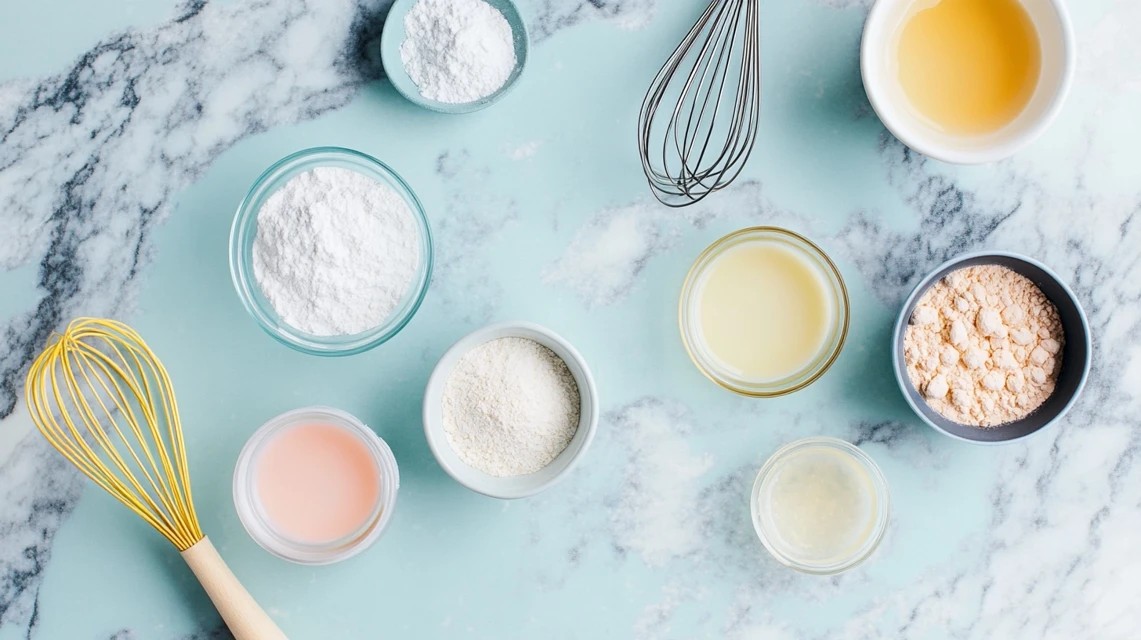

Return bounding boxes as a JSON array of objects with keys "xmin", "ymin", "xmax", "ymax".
[{"xmin": 759, "ymin": 447, "xmax": 876, "ymax": 564}]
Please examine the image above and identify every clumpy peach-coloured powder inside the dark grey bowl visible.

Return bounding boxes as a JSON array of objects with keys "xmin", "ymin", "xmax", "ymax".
[{"xmin": 904, "ymin": 265, "xmax": 1065, "ymax": 427}]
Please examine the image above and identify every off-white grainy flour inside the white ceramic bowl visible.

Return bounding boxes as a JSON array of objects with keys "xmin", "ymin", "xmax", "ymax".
[{"xmin": 443, "ymin": 338, "xmax": 581, "ymax": 477}]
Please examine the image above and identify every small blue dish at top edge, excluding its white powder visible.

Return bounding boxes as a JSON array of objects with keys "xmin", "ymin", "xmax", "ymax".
[{"xmin": 380, "ymin": 0, "xmax": 531, "ymax": 113}]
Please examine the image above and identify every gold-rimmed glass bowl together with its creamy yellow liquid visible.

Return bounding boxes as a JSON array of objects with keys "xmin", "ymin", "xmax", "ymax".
[{"xmin": 679, "ymin": 227, "xmax": 849, "ymax": 397}]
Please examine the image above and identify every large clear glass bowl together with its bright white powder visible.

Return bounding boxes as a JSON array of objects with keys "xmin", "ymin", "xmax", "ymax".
[{"xmin": 229, "ymin": 147, "xmax": 432, "ymax": 356}]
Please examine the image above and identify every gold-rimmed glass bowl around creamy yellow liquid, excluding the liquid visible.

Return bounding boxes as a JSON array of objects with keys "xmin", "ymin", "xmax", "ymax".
[{"xmin": 678, "ymin": 227, "xmax": 849, "ymax": 398}]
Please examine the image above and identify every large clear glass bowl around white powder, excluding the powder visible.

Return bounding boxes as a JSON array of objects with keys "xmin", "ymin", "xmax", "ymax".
[{"xmin": 229, "ymin": 147, "xmax": 432, "ymax": 356}]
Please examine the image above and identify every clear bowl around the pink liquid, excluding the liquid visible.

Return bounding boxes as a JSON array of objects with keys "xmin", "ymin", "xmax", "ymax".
[{"xmin": 234, "ymin": 406, "xmax": 400, "ymax": 565}]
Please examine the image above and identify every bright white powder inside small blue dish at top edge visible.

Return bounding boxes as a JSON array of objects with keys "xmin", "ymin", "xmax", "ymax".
[{"xmin": 400, "ymin": 0, "xmax": 517, "ymax": 104}]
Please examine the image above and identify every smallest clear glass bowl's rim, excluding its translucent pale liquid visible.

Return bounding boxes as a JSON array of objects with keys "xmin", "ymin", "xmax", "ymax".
[{"xmin": 750, "ymin": 437, "xmax": 891, "ymax": 575}]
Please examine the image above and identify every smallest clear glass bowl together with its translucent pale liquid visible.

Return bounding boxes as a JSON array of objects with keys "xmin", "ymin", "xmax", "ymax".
[{"xmin": 751, "ymin": 437, "xmax": 891, "ymax": 575}]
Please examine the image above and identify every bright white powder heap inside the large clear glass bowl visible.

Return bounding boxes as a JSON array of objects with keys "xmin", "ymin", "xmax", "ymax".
[{"xmin": 253, "ymin": 167, "xmax": 420, "ymax": 335}]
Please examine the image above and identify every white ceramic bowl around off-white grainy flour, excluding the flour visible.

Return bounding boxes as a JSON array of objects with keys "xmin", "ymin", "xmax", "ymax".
[{"xmin": 423, "ymin": 322, "xmax": 598, "ymax": 500}]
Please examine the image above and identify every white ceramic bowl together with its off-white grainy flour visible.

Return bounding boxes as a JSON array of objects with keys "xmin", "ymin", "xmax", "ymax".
[{"xmin": 423, "ymin": 322, "xmax": 599, "ymax": 499}]
